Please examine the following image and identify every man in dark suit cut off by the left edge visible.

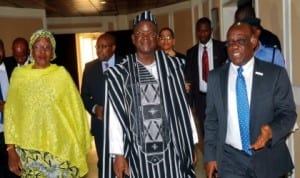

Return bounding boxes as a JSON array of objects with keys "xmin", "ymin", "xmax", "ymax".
[{"xmin": 0, "ymin": 39, "xmax": 18, "ymax": 178}]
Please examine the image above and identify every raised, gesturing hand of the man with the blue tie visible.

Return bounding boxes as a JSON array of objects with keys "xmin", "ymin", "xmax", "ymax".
[{"xmin": 251, "ymin": 125, "xmax": 272, "ymax": 150}]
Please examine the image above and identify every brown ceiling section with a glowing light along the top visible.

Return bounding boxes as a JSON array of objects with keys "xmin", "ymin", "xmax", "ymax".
[{"xmin": 0, "ymin": 0, "xmax": 187, "ymax": 17}]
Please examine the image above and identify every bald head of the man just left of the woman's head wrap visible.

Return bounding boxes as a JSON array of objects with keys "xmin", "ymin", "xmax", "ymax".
[{"xmin": 12, "ymin": 38, "xmax": 29, "ymax": 65}]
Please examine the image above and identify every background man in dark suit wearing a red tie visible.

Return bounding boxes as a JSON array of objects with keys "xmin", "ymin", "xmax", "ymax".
[{"xmin": 185, "ymin": 17, "xmax": 227, "ymax": 140}]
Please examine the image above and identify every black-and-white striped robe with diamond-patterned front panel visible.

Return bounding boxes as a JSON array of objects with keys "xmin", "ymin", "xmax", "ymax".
[{"xmin": 103, "ymin": 51, "xmax": 195, "ymax": 178}]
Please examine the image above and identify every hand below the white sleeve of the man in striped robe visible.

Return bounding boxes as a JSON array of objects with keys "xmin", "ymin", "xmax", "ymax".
[{"xmin": 114, "ymin": 155, "xmax": 129, "ymax": 178}]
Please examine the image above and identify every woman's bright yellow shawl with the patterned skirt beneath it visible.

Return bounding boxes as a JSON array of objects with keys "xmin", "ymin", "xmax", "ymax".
[{"xmin": 4, "ymin": 64, "xmax": 91, "ymax": 177}]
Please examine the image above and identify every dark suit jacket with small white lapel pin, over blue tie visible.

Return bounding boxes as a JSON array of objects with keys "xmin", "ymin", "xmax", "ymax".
[{"xmin": 204, "ymin": 59, "xmax": 296, "ymax": 178}]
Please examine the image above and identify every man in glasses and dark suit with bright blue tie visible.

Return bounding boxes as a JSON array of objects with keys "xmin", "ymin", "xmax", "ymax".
[{"xmin": 204, "ymin": 23, "xmax": 296, "ymax": 178}]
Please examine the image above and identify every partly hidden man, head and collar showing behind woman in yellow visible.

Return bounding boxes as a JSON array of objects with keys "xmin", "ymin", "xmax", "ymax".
[{"xmin": 7, "ymin": 37, "xmax": 30, "ymax": 66}]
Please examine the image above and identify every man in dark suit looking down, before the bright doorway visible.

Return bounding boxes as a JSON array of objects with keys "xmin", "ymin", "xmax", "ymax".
[{"xmin": 81, "ymin": 33, "xmax": 122, "ymax": 177}]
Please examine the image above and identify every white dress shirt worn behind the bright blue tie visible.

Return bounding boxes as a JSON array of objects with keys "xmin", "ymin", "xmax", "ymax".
[{"xmin": 225, "ymin": 57, "xmax": 254, "ymax": 150}]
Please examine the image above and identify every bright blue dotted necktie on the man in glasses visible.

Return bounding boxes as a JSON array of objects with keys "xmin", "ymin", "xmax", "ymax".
[{"xmin": 236, "ymin": 67, "xmax": 252, "ymax": 155}]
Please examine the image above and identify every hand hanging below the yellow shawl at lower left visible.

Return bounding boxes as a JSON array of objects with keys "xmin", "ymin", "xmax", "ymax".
[{"xmin": 7, "ymin": 145, "xmax": 22, "ymax": 176}]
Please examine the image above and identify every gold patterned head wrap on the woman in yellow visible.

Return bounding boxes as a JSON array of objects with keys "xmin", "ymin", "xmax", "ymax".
[{"xmin": 29, "ymin": 29, "xmax": 56, "ymax": 61}]
